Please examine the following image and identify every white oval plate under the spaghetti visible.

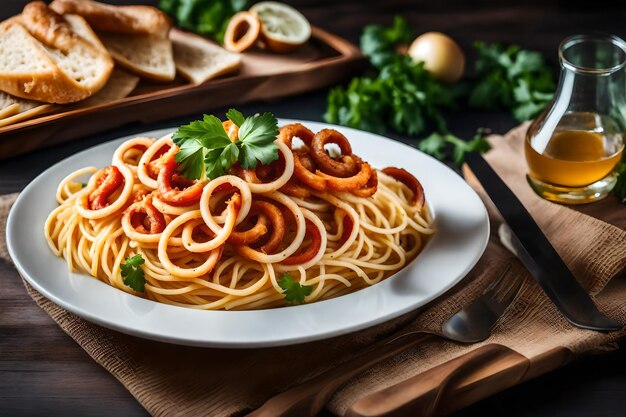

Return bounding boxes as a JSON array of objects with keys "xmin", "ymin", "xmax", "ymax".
[{"xmin": 7, "ymin": 120, "xmax": 489, "ymax": 348}]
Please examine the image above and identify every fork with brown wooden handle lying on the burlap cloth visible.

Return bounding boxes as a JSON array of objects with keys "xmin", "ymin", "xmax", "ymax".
[{"xmin": 248, "ymin": 267, "xmax": 522, "ymax": 417}]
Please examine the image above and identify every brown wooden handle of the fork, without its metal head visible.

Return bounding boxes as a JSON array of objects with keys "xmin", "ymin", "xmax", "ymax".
[{"xmin": 247, "ymin": 334, "xmax": 435, "ymax": 417}]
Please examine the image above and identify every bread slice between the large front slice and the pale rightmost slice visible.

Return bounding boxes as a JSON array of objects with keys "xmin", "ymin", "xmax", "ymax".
[{"xmin": 98, "ymin": 32, "xmax": 176, "ymax": 81}]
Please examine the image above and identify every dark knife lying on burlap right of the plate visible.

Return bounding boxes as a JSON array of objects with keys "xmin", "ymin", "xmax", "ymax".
[{"xmin": 465, "ymin": 152, "xmax": 623, "ymax": 332}]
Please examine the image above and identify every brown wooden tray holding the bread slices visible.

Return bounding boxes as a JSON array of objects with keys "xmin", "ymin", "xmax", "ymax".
[{"xmin": 0, "ymin": 27, "xmax": 366, "ymax": 160}]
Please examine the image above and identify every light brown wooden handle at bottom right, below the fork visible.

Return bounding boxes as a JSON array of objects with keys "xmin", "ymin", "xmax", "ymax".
[{"xmin": 345, "ymin": 344, "xmax": 530, "ymax": 417}]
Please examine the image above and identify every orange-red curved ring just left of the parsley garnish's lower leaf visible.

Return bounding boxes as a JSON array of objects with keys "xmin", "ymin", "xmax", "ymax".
[{"xmin": 157, "ymin": 147, "xmax": 205, "ymax": 207}]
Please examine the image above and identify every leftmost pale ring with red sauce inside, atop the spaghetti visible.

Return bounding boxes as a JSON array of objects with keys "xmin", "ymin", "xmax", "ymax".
[{"xmin": 76, "ymin": 165, "xmax": 135, "ymax": 219}]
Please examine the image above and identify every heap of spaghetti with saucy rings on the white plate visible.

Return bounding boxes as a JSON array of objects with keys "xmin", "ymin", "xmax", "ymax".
[{"xmin": 45, "ymin": 122, "xmax": 435, "ymax": 310}]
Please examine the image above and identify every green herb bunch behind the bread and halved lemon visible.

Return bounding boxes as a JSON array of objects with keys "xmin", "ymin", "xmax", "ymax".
[{"xmin": 159, "ymin": 0, "xmax": 248, "ymax": 42}]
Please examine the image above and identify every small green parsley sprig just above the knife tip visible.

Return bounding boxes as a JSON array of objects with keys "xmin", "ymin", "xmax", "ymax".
[{"xmin": 417, "ymin": 129, "xmax": 491, "ymax": 166}]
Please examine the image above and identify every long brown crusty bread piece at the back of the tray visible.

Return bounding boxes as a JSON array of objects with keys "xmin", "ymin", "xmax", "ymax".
[{"xmin": 49, "ymin": 0, "xmax": 172, "ymax": 38}]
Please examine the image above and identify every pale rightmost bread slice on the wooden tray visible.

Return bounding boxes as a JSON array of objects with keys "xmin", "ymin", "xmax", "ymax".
[{"xmin": 170, "ymin": 29, "xmax": 241, "ymax": 84}]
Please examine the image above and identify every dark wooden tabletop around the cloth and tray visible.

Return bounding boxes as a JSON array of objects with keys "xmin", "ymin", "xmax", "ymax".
[{"xmin": 0, "ymin": 0, "xmax": 626, "ymax": 417}]
